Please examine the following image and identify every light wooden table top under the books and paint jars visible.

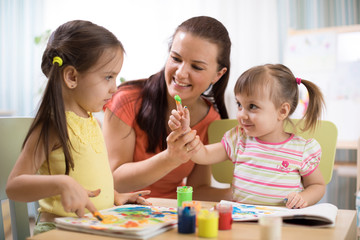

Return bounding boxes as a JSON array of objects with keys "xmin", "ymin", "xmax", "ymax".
[{"xmin": 28, "ymin": 198, "xmax": 356, "ymax": 240}]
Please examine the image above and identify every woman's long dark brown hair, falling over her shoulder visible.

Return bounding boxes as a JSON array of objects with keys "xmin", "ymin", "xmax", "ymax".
[{"xmin": 120, "ymin": 16, "xmax": 231, "ymax": 152}]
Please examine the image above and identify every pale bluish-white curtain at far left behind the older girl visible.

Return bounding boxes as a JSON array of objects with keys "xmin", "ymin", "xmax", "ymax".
[{"xmin": 0, "ymin": 0, "xmax": 43, "ymax": 116}]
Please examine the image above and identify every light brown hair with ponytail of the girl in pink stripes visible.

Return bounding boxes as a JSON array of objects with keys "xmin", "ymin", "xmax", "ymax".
[{"xmin": 234, "ymin": 64, "xmax": 325, "ymax": 131}]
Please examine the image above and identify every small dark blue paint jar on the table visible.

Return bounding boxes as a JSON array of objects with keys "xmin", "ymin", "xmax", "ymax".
[{"xmin": 178, "ymin": 206, "xmax": 196, "ymax": 233}]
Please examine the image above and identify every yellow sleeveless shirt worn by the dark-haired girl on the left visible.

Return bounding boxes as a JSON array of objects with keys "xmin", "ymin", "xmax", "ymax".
[{"xmin": 39, "ymin": 112, "xmax": 114, "ymax": 216}]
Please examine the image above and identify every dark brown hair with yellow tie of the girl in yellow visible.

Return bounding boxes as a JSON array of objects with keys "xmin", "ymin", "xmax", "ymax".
[{"xmin": 23, "ymin": 20, "xmax": 124, "ymax": 175}]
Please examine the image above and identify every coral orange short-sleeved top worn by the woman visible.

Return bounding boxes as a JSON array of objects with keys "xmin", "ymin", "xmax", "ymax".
[{"xmin": 104, "ymin": 88, "xmax": 220, "ymax": 198}]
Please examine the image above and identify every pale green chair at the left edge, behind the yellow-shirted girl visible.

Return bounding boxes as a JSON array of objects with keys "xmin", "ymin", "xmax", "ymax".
[{"xmin": 0, "ymin": 118, "xmax": 33, "ymax": 240}]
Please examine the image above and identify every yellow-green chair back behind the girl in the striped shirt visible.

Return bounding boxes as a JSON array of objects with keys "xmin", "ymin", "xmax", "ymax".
[{"xmin": 208, "ymin": 119, "xmax": 337, "ymax": 184}]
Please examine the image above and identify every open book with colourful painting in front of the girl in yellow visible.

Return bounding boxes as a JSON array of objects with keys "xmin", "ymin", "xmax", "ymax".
[{"xmin": 55, "ymin": 205, "xmax": 177, "ymax": 239}]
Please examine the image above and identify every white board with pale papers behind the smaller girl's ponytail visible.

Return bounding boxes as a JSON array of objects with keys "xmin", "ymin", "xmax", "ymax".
[{"xmin": 284, "ymin": 26, "xmax": 360, "ymax": 141}]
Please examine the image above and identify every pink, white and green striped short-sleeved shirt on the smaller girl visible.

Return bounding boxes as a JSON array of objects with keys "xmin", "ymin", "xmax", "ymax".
[{"xmin": 221, "ymin": 126, "xmax": 321, "ymax": 205}]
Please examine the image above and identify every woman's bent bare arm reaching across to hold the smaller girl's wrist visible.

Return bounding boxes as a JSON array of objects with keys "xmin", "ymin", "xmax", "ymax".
[{"xmin": 103, "ymin": 109, "xmax": 195, "ymax": 192}]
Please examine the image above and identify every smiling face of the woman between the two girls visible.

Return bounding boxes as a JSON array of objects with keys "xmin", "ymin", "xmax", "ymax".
[{"xmin": 165, "ymin": 31, "xmax": 226, "ymax": 105}]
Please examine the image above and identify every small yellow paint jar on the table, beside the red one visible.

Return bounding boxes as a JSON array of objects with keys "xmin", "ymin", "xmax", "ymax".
[{"xmin": 197, "ymin": 209, "xmax": 219, "ymax": 238}]
